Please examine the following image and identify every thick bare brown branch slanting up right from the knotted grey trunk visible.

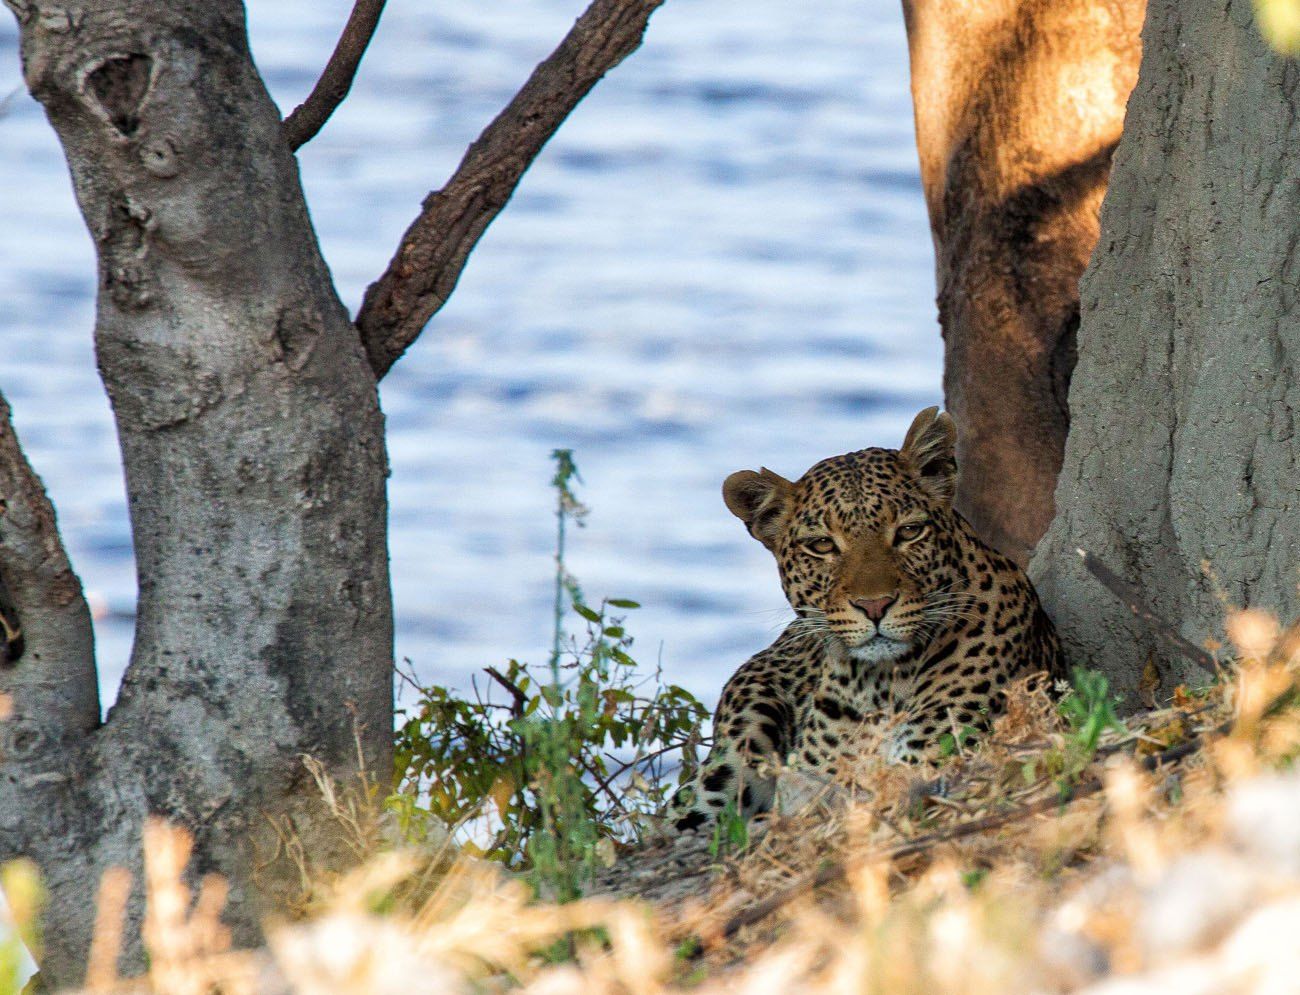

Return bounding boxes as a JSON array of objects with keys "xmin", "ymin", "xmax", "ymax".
[{"xmin": 356, "ymin": 0, "xmax": 663, "ymax": 377}]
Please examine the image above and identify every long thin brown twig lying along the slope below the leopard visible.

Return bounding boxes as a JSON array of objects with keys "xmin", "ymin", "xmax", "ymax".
[{"xmin": 716, "ymin": 723, "xmax": 1211, "ymax": 940}]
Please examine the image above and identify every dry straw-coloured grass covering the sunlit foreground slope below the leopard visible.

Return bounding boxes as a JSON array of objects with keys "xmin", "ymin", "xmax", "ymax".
[{"xmin": 15, "ymin": 613, "xmax": 1300, "ymax": 995}]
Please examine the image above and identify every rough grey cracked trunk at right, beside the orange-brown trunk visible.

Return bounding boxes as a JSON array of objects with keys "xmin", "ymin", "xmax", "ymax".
[{"xmin": 1034, "ymin": 0, "xmax": 1300, "ymax": 692}]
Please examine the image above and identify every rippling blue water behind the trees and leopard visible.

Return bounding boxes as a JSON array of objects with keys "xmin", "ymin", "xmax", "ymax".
[{"xmin": 0, "ymin": 0, "xmax": 941, "ymax": 701}]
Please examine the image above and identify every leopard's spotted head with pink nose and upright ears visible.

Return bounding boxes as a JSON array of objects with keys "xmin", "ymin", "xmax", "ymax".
[{"xmin": 723, "ymin": 407, "xmax": 961, "ymax": 662}]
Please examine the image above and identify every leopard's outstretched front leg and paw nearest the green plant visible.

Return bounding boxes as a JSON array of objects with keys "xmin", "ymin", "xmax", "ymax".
[{"xmin": 672, "ymin": 654, "xmax": 796, "ymax": 830}]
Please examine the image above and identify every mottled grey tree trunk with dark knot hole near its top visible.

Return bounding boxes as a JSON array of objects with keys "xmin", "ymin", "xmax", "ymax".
[{"xmin": 0, "ymin": 0, "xmax": 393, "ymax": 985}]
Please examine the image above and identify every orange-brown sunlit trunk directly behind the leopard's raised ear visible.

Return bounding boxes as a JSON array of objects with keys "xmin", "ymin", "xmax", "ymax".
[{"xmin": 904, "ymin": 0, "xmax": 1144, "ymax": 563}]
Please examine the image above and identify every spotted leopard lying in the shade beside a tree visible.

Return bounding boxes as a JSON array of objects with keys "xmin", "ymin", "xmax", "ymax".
[{"xmin": 670, "ymin": 406, "xmax": 1063, "ymax": 830}]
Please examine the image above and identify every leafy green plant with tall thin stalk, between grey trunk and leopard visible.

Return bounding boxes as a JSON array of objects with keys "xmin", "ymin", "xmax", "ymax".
[{"xmin": 387, "ymin": 450, "xmax": 709, "ymax": 900}]
